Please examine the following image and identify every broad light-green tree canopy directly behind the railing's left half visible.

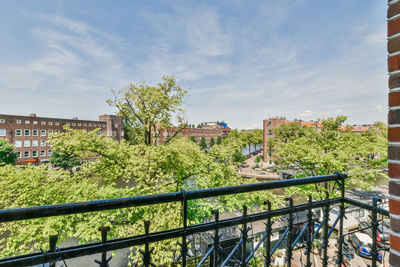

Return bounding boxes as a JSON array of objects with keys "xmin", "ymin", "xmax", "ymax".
[{"xmin": 0, "ymin": 128, "xmax": 281, "ymax": 266}]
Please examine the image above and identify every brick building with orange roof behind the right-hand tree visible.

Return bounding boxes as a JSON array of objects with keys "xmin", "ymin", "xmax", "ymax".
[{"xmin": 263, "ymin": 117, "xmax": 374, "ymax": 165}]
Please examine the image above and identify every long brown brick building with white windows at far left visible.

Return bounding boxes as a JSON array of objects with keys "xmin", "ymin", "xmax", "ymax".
[{"xmin": 0, "ymin": 114, "xmax": 123, "ymax": 164}]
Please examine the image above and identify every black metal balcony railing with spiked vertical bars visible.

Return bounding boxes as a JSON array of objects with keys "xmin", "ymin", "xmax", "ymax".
[{"xmin": 0, "ymin": 173, "xmax": 389, "ymax": 267}]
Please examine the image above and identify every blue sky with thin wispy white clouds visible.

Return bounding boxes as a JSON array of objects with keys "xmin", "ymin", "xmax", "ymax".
[{"xmin": 0, "ymin": 0, "xmax": 388, "ymax": 128}]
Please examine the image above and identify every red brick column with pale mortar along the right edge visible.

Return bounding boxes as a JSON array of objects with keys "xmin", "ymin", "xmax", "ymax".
[{"xmin": 387, "ymin": 0, "xmax": 400, "ymax": 267}]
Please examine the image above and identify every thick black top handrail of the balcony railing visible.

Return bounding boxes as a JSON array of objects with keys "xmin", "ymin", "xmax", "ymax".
[{"xmin": 0, "ymin": 173, "xmax": 347, "ymax": 223}]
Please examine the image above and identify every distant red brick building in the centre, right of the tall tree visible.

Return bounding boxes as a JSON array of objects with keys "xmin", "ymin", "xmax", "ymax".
[{"xmin": 160, "ymin": 122, "xmax": 231, "ymax": 144}]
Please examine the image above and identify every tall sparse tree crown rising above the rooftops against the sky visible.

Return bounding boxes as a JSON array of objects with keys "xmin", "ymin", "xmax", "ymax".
[{"xmin": 107, "ymin": 76, "xmax": 187, "ymax": 145}]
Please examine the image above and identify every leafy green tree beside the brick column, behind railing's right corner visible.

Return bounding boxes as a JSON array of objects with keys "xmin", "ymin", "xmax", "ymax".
[{"xmin": 272, "ymin": 116, "xmax": 387, "ymax": 200}]
